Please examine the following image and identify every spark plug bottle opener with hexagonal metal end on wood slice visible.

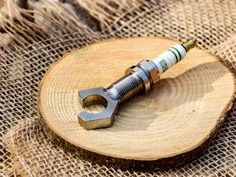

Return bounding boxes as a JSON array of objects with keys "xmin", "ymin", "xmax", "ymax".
[{"xmin": 78, "ymin": 39, "xmax": 196, "ymax": 130}]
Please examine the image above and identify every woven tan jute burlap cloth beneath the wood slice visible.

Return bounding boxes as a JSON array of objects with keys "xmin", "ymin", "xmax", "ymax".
[{"xmin": 0, "ymin": 0, "xmax": 236, "ymax": 176}]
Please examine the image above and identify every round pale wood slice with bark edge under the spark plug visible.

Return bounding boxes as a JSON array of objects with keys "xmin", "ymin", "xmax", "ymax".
[{"xmin": 39, "ymin": 37, "xmax": 235, "ymax": 165}]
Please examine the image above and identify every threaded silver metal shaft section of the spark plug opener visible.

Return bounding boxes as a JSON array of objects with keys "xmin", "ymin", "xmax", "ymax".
[{"xmin": 106, "ymin": 72, "xmax": 144, "ymax": 103}]
